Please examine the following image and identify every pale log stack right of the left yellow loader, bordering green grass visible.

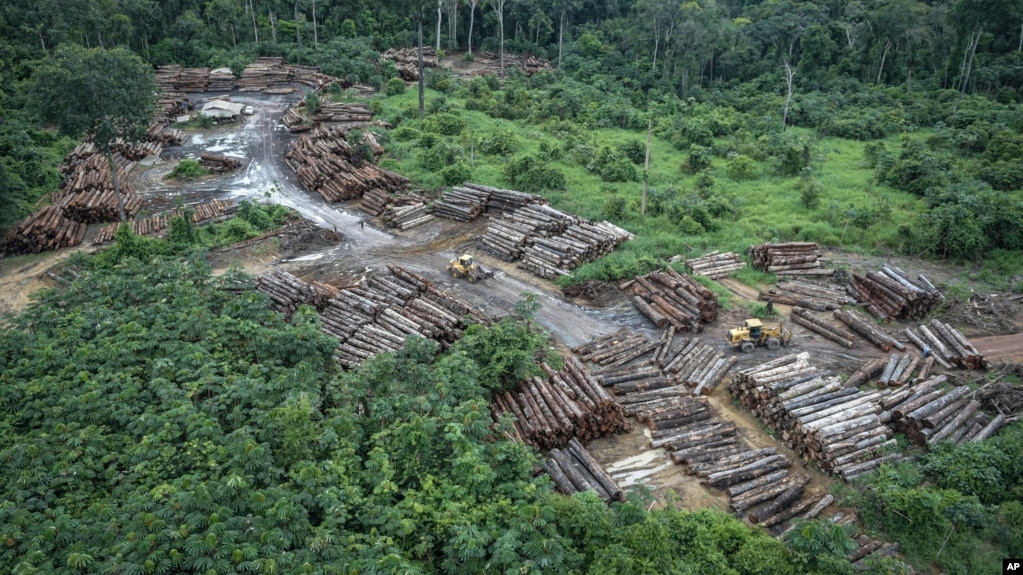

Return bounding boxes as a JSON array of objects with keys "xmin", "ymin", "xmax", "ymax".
[{"xmin": 480, "ymin": 203, "xmax": 634, "ymax": 279}]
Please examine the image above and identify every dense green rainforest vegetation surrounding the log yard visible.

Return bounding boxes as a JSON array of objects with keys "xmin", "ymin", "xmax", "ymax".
[{"xmin": 0, "ymin": 0, "xmax": 1023, "ymax": 575}]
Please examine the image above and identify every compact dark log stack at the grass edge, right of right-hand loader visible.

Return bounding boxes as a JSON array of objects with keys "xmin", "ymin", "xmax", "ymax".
[{"xmin": 848, "ymin": 265, "xmax": 943, "ymax": 319}]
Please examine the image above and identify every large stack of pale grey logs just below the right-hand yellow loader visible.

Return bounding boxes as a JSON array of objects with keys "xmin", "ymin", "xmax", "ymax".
[{"xmin": 728, "ymin": 353, "xmax": 902, "ymax": 481}]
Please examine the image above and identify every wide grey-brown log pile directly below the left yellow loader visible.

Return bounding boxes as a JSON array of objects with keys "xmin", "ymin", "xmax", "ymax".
[{"xmin": 320, "ymin": 265, "xmax": 486, "ymax": 367}]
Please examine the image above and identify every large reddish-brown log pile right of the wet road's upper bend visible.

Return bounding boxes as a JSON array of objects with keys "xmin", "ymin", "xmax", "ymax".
[{"xmin": 284, "ymin": 126, "xmax": 408, "ymax": 202}]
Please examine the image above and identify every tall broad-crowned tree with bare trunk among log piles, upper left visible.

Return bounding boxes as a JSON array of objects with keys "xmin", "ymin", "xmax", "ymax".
[{"xmin": 31, "ymin": 44, "xmax": 157, "ymax": 221}]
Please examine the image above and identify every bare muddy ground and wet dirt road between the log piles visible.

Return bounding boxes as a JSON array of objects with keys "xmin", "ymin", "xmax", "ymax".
[{"xmin": 0, "ymin": 88, "xmax": 1023, "ymax": 519}]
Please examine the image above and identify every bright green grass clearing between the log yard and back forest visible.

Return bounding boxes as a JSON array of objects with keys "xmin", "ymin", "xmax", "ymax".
[{"xmin": 377, "ymin": 89, "xmax": 990, "ymax": 282}]
